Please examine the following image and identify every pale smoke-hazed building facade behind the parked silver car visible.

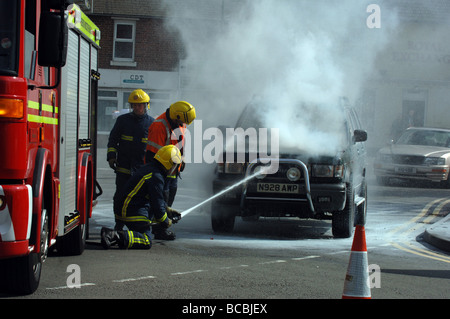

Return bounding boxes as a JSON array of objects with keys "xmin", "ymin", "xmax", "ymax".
[{"xmin": 357, "ymin": 0, "xmax": 450, "ymax": 150}]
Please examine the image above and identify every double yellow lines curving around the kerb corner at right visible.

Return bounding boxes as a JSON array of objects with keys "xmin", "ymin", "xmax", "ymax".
[{"xmin": 388, "ymin": 198, "xmax": 450, "ymax": 263}]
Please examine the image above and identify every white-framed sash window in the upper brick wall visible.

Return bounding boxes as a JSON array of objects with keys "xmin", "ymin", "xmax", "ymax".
[{"xmin": 111, "ymin": 20, "xmax": 136, "ymax": 66}]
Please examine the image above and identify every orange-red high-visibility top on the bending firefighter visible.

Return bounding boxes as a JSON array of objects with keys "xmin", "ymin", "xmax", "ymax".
[{"xmin": 145, "ymin": 109, "xmax": 186, "ymax": 162}]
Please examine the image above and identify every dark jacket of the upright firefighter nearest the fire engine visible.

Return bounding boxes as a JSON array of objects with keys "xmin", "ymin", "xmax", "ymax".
[{"xmin": 106, "ymin": 112, "xmax": 154, "ymax": 174}]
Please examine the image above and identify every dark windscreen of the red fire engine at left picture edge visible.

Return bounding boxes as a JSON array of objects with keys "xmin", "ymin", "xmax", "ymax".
[{"xmin": 0, "ymin": 1, "xmax": 19, "ymax": 75}]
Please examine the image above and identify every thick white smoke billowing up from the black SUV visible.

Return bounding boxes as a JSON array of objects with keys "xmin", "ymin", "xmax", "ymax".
[{"xmin": 161, "ymin": 0, "xmax": 396, "ymax": 154}]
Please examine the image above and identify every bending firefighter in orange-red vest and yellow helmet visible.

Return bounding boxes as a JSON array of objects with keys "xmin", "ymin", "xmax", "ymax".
[{"xmin": 145, "ymin": 101, "xmax": 196, "ymax": 206}]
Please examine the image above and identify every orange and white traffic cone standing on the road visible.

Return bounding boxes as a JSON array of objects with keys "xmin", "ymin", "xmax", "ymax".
[{"xmin": 342, "ymin": 225, "xmax": 371, "ymax": 299}]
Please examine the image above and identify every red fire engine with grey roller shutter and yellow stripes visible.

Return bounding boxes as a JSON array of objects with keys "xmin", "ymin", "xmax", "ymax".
[{"xmin": 0, "ymin": 0, "xmax": 101, "ymax": 293}]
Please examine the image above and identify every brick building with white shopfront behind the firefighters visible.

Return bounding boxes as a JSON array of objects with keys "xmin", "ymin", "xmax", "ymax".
[{"xmin": 88, "ymin": 0, "xmax": 183, "ymax": 147}]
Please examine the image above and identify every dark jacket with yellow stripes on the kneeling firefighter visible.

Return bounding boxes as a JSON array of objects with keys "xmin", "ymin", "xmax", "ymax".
[{"xmin": 114, "ymin": 159, "xmax": 169, "ymax": 227}]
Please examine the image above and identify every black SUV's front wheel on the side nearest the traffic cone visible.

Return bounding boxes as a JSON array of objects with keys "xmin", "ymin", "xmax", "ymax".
[{"xmin": 331, "ymin": 184, "xmax": 355, "ymax": 238}]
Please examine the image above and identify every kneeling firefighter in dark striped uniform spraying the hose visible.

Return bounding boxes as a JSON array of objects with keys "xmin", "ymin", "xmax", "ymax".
[{"xmin": 101, "ymin": 145, "xmax": 182, "ymax": 249}]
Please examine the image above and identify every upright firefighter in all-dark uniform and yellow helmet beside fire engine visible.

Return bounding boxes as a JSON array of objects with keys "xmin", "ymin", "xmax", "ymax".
[{"xmin": 106, "ymin": 89, "xmax": 154, "ymax": 229}]
